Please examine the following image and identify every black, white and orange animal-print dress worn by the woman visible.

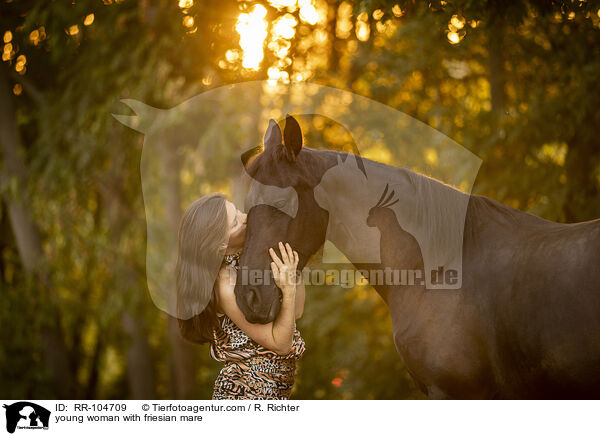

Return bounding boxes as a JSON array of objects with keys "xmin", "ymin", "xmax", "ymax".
[{"xmin": 210, "ymin": 253, "xmax": 305, "ymax": 400}]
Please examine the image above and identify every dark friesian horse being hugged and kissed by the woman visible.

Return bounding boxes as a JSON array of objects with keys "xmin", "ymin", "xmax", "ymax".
[{"xmin": 235, "ymin": 116, "xmax": 600, "ymax": 398}]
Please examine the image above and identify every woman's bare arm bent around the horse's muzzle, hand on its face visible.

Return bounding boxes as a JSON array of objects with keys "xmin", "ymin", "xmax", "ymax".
[{"xmin": 218, "ymin": 245, "xmax": 297, "ymax": 355}]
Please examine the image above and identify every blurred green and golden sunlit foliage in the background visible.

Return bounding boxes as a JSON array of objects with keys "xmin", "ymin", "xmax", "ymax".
[{"xmin": 0, "ymin": 0, "xmax": 600, "ymax": 399}]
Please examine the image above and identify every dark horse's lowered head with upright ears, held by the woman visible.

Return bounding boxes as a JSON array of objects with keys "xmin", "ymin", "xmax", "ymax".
[{"xmin": 234, "ymin": 115, "xmax": 328, "ymax": 324}]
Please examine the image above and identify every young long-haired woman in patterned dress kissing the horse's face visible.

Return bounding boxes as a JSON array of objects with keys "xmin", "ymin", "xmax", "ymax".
[{"xmin": 176, "ymin": 194, "xmax": 305, "ymax": 399}]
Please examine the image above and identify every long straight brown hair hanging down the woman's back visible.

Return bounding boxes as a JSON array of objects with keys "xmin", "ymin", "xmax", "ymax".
[{"xmin": 175, "ymin": 193, "xmax": 228, "ymax": 344}]
